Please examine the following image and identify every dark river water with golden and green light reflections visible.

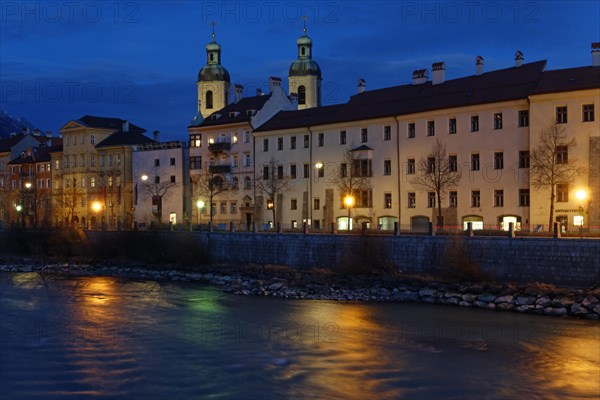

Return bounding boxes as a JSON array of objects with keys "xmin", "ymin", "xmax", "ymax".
[{"xmin": 0, "ymin": 273, "xmax": 600, "ymax": 400}]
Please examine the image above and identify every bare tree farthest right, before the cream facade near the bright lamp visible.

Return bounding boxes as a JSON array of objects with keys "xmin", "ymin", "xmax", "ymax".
[{"xmin": 529, "ymin": 124, "xmax": 585, "ymax": 226}]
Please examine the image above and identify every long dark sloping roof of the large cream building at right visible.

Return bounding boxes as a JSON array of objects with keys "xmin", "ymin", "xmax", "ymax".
[{"xmin": 255, "ymin": 60, "xmax": 600, "ymax": 132}]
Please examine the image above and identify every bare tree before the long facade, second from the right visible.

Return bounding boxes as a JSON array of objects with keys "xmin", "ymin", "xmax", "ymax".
[{"xmin": 410, "ymin": 139, "xmax": 462, "ymax": 227}]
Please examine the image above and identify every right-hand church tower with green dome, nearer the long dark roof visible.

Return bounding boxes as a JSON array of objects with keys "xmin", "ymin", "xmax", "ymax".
[{"xmin": 288, "ymin": 18, "xmax": 321, "ymax": 110}]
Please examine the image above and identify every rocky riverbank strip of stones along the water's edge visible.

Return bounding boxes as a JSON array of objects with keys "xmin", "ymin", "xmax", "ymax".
[{"xmin": 0, "ymin": 259, "xmax": 600, "ymax": 320}]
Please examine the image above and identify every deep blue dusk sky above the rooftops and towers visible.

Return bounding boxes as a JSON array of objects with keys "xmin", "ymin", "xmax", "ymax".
[{"xmin": 0, "ymin": 0, "xmax": 600, "ymax": 140}]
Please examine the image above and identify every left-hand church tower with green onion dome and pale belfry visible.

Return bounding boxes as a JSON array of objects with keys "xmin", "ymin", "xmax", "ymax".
[{"xmin": 198, "ymin": 22, "xmax": 231, "ymax": 118}]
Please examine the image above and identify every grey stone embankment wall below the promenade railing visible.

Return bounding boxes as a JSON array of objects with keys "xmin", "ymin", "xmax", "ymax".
[{"xmin": 86, "ymin": 231, "xmax": 600, "ymax": 288}]
